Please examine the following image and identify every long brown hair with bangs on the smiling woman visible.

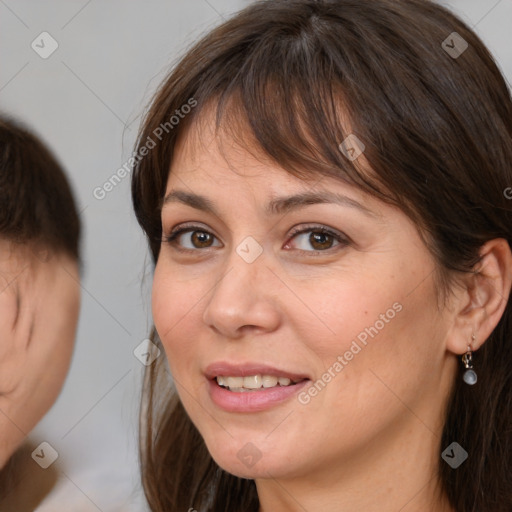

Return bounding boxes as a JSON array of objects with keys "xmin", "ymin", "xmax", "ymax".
[{"xmin": 132, "ymin": 0, "xmax": 512, "ymax": 512}]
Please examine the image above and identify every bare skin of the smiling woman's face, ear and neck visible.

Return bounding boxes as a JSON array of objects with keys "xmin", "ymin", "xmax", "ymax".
[{"xmin": 152, "ymin": 114, "xmax": 512, "ymax": 512}]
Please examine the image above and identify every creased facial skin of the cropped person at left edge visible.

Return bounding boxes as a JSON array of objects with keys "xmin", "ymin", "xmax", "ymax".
[{"xmin": 0, "ymin": 240, "xmax": 80, "ymax": 467}]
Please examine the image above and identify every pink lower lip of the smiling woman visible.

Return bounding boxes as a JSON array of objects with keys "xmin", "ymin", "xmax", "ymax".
[{"xmin": 209, "ymin": 379, "xmax": 309, "ymax": 412}]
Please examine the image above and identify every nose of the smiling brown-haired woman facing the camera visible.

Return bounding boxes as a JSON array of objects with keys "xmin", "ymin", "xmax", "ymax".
[{"xmin": 203, "ymin": 250, "xmax": 280, "ymax": 339}]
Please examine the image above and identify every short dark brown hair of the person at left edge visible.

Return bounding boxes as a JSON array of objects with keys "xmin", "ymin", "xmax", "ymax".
[{"xmin": 0, "ymin": 119, "xmax": 81, "ymax": 261}]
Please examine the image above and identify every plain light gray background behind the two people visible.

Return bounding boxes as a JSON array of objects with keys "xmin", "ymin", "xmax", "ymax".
[{"xmin": 0, "ymin": 0, "xmax": 512, "ymax": 512}]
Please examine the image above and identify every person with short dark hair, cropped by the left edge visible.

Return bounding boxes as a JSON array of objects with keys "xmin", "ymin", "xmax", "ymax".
[{"xmin": 0, "ymin": 119, "xmax": 80, "ymax": 492}]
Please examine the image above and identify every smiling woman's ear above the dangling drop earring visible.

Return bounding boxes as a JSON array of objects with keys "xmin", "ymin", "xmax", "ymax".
[{"xmin": 446, "ymin": 238, "xmax": 512, "ymax": 354}]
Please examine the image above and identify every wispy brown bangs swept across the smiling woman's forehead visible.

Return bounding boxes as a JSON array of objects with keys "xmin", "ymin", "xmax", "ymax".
[{"xmin": 180, "ymin": 30, "xmax": 397, "ymax": 204}]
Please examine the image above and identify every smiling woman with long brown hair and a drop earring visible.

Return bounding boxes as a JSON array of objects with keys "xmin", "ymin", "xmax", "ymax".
[{"xmin": 132, "ymin": 0, "xmax": 512, "ymax": 512}]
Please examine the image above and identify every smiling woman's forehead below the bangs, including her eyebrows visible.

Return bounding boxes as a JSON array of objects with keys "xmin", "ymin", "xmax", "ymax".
[{"xmin": 163, "ymin": 109, "xmax": 381, "ymax": 218}]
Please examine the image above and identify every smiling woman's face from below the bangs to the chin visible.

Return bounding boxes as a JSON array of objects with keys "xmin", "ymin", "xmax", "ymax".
[{"xmin": 153, "ymin": 115, "xmax": 456, "ymax": 478}]
